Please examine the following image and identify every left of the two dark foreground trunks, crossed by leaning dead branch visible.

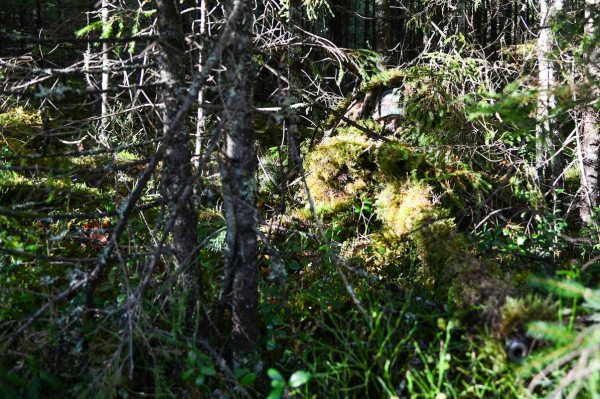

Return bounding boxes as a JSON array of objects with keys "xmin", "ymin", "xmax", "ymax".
[{"xmin": 156, "ymin": 0, "xmax": 202, "ymax": 321}]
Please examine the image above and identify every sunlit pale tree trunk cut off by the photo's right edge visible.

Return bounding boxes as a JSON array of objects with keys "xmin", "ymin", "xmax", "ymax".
[{"xmin": 580, "ymin": 0, "xmax": 600, "ymax": 223}]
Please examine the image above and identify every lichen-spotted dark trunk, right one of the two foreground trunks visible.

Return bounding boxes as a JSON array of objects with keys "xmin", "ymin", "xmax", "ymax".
[{"xmin": 223, "ymin": 0, "xmax": 261, "ymax": 370}]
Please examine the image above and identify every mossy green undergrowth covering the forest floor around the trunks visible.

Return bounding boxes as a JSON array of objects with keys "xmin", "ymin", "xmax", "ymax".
[{"xmin": 0, "ymin": 62, "xmax": 600, "ymax": 399}]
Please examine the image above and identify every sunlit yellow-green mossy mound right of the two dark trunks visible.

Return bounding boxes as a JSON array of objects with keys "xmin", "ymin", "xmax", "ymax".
[{"xmin": 303, "ymin": 128, "xmax": 513, "ymax": 329}]
